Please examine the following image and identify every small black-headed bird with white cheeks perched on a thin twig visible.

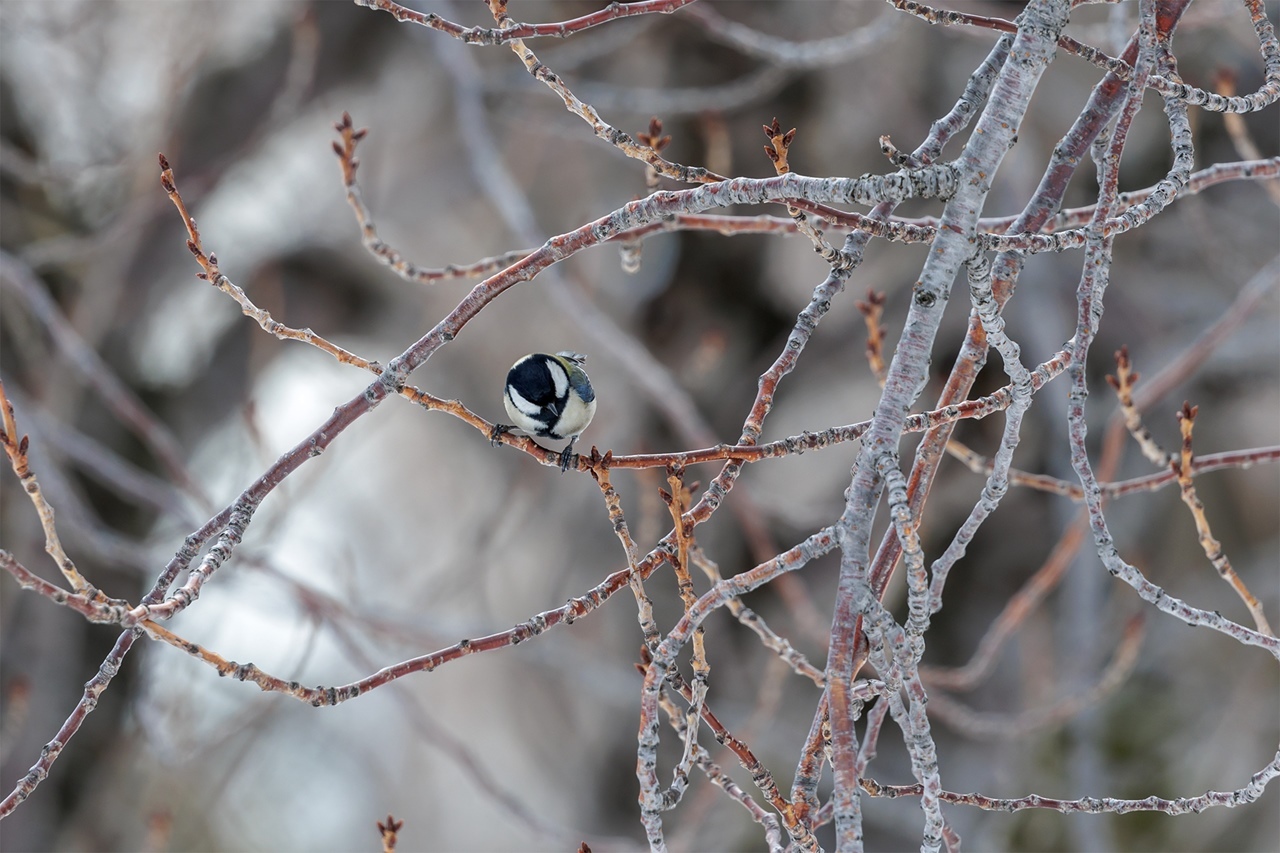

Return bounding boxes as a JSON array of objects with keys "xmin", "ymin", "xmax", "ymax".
[{"xmin": 489, "ymin": 351, "xmax": 595, "ymax": 471}]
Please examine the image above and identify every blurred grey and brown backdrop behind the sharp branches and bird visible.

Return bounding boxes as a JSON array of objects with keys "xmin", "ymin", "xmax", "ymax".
[{"xmin": 0, "ymin": 0, "xmax": 1280, "ymax": 850}]
